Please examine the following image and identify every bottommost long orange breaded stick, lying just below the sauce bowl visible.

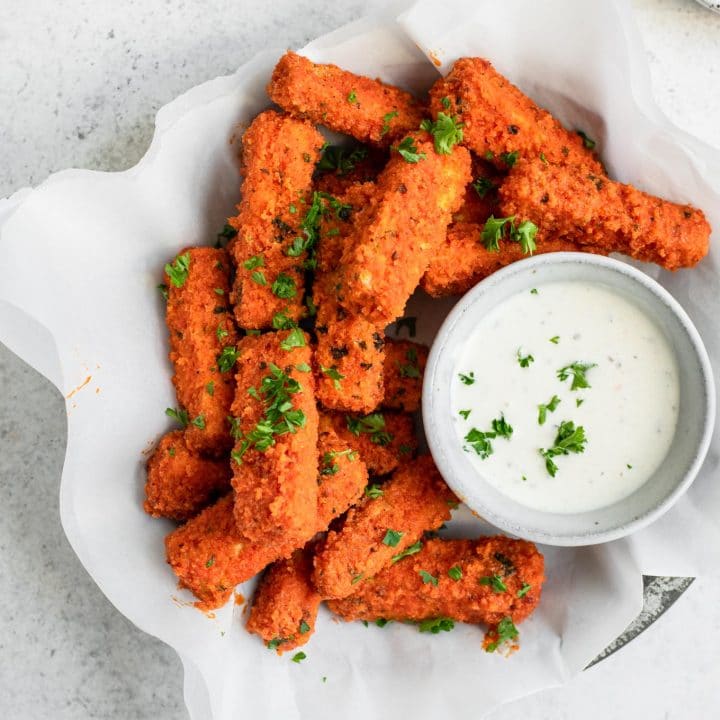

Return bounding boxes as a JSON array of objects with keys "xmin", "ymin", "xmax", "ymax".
[{"xmin": 328, "ymin": 536, "xmax": 545, "ymax": 625}]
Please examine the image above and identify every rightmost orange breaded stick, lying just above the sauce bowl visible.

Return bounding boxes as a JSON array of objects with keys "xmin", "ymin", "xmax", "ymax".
[{"xmin": 499, "ymin": 162, "xmax": 710, "ymax": 270}]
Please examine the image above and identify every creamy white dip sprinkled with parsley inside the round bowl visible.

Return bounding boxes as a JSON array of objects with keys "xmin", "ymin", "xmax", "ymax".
[{"xmin": 451, "ymin": 282, "xmax": 679, "ymax": 513}]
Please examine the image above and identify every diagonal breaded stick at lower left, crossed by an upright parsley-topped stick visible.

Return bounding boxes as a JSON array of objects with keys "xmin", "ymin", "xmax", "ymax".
[{"xmin": 165, "ymin": 422, "xmax": 368, "ymax": 610}]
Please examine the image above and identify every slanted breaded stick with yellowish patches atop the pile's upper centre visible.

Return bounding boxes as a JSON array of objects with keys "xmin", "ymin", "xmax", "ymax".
[{"xmin": 338, "ymin": 133, "xmax": 470, "ymax": 325}]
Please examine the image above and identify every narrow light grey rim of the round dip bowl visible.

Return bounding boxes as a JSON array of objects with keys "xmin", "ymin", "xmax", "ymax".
[{"xmin": 422, "ymin": 252, "xmax": 716, "ymax": 547}]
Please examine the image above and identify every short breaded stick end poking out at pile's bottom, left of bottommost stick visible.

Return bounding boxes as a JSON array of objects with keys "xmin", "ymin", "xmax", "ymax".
[{"xmin": 246, "ymin": 549, "xmax": 321, "ymax": 655}]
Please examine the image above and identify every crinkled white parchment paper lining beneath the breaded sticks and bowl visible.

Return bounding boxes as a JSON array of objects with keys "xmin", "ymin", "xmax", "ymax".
[{"xmin": 0, "ymin": 0, "xmax": 720, "ymax": 720}]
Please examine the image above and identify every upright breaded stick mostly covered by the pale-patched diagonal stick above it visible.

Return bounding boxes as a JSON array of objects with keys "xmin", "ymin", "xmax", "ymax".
[{"xmin": 313, "ymin": 273, "xmax": 385, "ymax": 413}]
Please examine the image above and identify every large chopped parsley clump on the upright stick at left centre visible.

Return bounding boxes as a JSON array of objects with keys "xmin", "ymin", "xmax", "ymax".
[{"xmin": 231, "ymin": 363, "xmax": 305, "ymax": 463}]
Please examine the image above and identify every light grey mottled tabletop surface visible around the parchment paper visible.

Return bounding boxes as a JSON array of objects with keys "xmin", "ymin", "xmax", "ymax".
[{"xmin": 0, "ymin": 0, "xmax": 720, "ymax": 720}]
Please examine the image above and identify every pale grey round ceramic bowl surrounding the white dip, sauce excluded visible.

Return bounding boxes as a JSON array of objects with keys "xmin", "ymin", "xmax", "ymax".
[{"xmin": 422, "ymin": 253, "xmax": 715, "ymax": 545}]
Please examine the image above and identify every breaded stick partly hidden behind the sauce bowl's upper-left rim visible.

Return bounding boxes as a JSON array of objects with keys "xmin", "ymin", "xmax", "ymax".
[{"xmin": 420, "ymin": 222, "xmax": 584, "ymax": 297}]
